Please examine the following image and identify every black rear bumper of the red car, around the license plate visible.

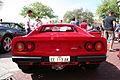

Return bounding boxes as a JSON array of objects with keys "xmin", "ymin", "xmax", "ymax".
[{"xmin": 12, "ymin": 55, "xmax": 106, "ymax": 65}]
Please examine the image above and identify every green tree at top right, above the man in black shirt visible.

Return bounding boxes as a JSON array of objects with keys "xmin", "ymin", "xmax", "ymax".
[{"xmin": 97, "ymin": 0, "xmax": 119, "ymax": 18}]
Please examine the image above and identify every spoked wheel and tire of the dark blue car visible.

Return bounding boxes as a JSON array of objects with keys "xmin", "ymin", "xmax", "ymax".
[{"xmin": 1, "ymin": 35, "xmax": 12, "ymax": 53}]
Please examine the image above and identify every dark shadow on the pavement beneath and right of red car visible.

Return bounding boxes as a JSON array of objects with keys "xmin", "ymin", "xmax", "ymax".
[{"xmin": 31, "ymin": 62, "xmax": 120, "ymax": 80}]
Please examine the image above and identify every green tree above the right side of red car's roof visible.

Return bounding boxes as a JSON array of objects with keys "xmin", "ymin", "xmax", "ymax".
[{"xmin": 63, "ymin": 8, "xmax": 93, "ymax": 23}]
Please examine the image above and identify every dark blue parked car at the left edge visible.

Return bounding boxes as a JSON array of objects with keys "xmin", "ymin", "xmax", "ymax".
[{"xmin": 0, "ymin": 22, "xmax": 25, "ymax": 53}]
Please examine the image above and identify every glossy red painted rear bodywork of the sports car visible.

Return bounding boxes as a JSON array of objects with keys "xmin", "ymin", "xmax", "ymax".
[{"xmin": 12, "ymin": 24, "xmax": 107, "ymax": 56}]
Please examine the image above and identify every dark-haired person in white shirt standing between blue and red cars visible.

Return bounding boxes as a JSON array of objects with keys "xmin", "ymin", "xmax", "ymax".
[{"xmin": 25, "ymin": 10, "xmax": 33, "ymax": 34}]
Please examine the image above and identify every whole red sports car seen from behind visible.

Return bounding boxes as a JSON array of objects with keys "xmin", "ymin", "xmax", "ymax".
[{"xmin": 12, "ymin": 24, "xmax": 107, "ymax": 72}]
